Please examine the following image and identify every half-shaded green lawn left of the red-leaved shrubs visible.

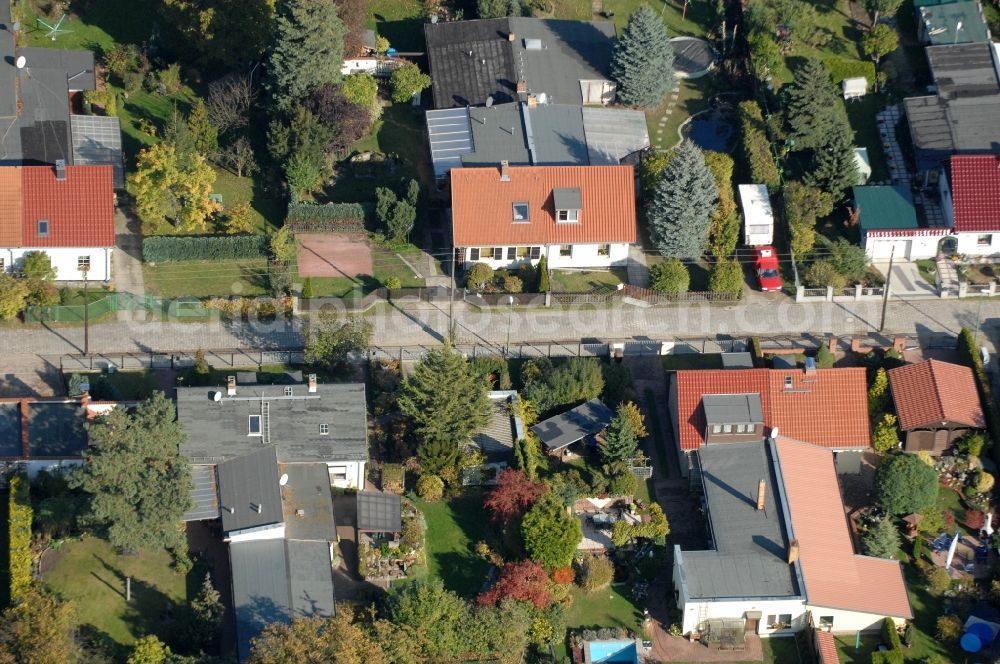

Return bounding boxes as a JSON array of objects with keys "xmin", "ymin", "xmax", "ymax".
[{"xmin": 413, "ymin": 491, "xmax": 489, "ymax": 597}]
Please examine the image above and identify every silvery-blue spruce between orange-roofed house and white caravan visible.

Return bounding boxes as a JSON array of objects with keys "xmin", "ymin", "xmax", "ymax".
[{"xmin": 646, "ymin": 141, "xmax": 718, "ymax": 258}]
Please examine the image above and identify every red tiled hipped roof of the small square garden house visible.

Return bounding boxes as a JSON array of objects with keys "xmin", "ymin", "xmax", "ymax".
[{"xmin": 889, "ymin": 360, "xmax": 986, "ymax": 431}]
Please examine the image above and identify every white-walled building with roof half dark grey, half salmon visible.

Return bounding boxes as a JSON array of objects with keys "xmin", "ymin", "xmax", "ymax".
[{"xmin": 673, "ymin": 435, "xmax": 913, "ymax": 647}]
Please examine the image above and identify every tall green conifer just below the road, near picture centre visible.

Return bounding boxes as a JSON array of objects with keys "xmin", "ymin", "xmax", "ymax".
[{"xmin": 398, "ymin": 341, "xmax": 490, "ymax": 472}]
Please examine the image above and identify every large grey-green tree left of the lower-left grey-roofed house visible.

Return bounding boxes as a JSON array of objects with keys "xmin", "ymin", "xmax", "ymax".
[{"xmin": 69, "ymin": 392, "xmax": 192, "ymax": 556}]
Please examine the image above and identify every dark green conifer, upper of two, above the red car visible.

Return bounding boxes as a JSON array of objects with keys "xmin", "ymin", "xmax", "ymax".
[{"xmin": 786, "ymin": 58, "xmax": 847, "ymax": 150}]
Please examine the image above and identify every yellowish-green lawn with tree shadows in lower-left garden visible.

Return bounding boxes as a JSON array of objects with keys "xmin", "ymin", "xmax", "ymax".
[{"xmin": 45, "ymin": 537, "xmax": 187, "ymax": 645}]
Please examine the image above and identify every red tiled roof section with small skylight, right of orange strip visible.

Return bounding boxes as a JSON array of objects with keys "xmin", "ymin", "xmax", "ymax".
[{"xmin": 20, "ymin": 165, "xmax": 115, "ymax": 247}]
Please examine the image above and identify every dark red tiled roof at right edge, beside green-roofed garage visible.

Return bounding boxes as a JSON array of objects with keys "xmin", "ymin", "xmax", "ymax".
[{"xmin": 951, "ymin": 154, "xmax": 1000, "ymax": 231}]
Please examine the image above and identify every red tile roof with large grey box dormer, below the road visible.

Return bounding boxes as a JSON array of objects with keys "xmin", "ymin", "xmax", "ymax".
[{"xmin": 668, "ymin": 368, "xmax": 871, "ymax": 475}]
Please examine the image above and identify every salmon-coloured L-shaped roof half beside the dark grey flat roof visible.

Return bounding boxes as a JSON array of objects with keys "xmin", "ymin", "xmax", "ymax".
[{"xmin": 776, "ymin": 436, "xmax": 913, "ymax": 618}]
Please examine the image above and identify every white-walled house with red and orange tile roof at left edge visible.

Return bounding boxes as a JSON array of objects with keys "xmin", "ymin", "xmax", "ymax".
[{"xmin": 0, "ymin": 165, "xmax": 115, "ymax": 281}]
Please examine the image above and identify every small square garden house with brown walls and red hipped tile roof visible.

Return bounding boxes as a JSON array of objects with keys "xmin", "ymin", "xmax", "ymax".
[{"xmin": 889, "ymin": 360, "xmax": 986, "ymax": 454}]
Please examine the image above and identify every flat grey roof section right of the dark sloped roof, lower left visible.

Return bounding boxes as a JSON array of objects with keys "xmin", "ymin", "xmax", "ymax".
[{"xmin": 280, "ymin": 463, "xmax": 337, "ymax": 541}]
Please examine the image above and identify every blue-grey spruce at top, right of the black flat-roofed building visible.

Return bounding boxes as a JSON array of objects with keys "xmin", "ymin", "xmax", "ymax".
[{"xmin": 611, "ymin": 5, "xmax": 674, "ymax": 106}]
